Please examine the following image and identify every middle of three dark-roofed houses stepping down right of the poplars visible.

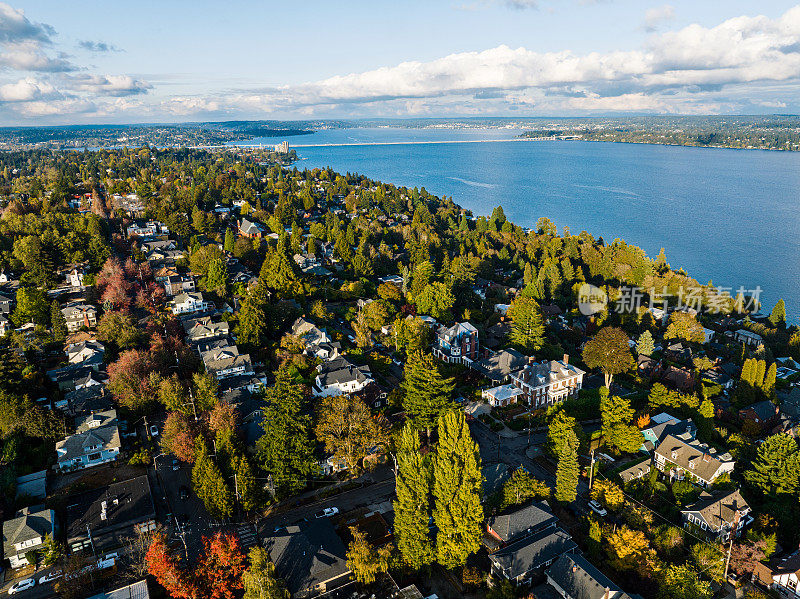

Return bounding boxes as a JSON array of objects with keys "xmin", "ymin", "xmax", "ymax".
[{"xmin": 489, "ymin": 527, "xmax": 578, "ymax": 584}]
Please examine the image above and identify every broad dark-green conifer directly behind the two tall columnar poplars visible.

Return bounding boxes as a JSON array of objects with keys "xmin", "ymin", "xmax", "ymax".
[{"xmin": 401, "ymin": 352, "xmax": 455, "ymax": 441}]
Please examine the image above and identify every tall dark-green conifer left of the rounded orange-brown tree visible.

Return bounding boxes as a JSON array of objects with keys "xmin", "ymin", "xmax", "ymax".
[{"xmin": 256, "ymin": 368, "xmax": 317, "ymax": 497}]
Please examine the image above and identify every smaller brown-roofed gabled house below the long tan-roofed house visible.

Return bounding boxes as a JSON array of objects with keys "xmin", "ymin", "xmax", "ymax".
[{"xmin": 681, "ymin": 489, "xmax": 753, "ymax": 542}]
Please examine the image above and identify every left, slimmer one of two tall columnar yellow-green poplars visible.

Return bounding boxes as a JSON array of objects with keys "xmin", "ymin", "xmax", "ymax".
[{"xmin": 394, "ymin": 424, "xmax": 433, "ymax": 570}]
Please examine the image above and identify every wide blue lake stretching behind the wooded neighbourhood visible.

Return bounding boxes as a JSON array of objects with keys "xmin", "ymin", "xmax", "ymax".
[{"xmin": 241, "ymin": 128, "xmax": 800, "ymax": 322}]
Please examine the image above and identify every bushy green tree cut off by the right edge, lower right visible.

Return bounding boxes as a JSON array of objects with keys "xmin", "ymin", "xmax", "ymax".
[{"xmin": 744, "ymin": 433, "xmax": 800, "ymax": 498}]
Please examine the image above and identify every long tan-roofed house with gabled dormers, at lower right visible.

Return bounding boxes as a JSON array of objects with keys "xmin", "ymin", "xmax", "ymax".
[{"xmin": 654, "ymin": 434, "xmax": 735, "ymax": 487}]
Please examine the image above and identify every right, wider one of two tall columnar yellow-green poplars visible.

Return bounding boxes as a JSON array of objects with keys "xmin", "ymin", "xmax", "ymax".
[{"xmin": 433, "ymin": 410, "xmax": 483, "ymax": 569}]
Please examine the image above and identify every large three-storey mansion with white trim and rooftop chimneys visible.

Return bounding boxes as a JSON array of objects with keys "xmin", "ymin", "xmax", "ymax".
[{"xmin": 511, "ymin": 356, "xmax": 586, "ymax": 408}]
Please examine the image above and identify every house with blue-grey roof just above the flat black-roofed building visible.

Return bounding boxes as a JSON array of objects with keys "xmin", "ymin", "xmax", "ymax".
[{"xmin": 56, "ymin": 409, "xmax": 122, "ymax": 471}]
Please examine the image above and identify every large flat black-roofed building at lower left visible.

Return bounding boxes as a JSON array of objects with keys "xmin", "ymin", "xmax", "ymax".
[{"xmin": 66, "ymin": 474, "xmax": 156, "ymax": 553}]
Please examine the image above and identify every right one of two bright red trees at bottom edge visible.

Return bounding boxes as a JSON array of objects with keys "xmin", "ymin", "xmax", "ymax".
[{"xmin": 197, "ymin": 532, "xmax": 245, "ymax": 599}]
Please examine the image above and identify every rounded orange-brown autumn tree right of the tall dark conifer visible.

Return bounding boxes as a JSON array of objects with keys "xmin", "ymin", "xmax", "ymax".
[{"xmin": 316, "ymin": 395, "xmax": 386, "ymax": 473}]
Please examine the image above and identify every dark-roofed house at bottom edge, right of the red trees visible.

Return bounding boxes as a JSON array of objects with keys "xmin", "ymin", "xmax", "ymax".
[{"xmin": 264, "ymin": 518, "xmax": 350, "ymax": 598}]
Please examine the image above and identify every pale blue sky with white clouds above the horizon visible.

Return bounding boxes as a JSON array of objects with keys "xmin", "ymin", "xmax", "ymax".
[{"xmin": 0, "ymin": 0, "xmax": 800, "ymax": 125}]
